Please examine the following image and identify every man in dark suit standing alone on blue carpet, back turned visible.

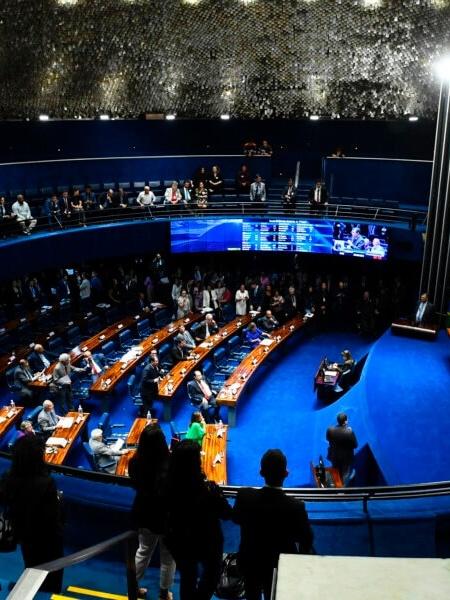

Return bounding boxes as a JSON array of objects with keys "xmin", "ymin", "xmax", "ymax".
[{"xmin": 327, "ymin": 413, "xmax": 358, "ymax": 486}]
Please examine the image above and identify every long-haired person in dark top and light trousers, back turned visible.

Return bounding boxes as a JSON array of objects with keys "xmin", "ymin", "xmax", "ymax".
[{"xmin": 128, "ymin": 423, "xmax": 175, "ymax": 600}]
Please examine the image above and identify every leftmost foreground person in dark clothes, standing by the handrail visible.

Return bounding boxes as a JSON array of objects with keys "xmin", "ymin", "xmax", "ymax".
[{"xmin": 0, "ymin": 435, "xmax": 63, "ymax": 593}]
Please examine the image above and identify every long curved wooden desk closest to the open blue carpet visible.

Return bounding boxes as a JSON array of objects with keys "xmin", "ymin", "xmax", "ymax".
[{"xmin": 217, "ymin": 315, "xmax": 307, "ymax": 427}]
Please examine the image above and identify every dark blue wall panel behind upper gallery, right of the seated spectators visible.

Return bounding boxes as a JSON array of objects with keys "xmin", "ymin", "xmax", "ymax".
[{"xmin": 324, "ymin": 158, "xmax": 432, "ymax": 206}]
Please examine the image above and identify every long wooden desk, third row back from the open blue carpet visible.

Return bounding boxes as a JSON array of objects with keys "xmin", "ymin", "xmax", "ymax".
[{"xmin": 90, "ymin": 314, "xmax": 204, "ymax": 395}]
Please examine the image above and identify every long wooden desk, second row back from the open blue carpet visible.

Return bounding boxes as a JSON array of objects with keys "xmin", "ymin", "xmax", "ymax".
[{"xmin": 158, "ymin": 315, "xmax": 254, "ymax": 421}]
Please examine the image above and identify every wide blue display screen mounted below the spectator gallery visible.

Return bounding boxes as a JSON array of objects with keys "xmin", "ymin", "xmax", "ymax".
[{"xmin": 171, "ymin": 218, "xmax": 388, "ymax": 260}]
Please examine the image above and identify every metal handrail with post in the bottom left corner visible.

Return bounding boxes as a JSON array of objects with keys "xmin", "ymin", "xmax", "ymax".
[{"xmin": 7, "ymin": 531, "xmax": 138, "ymax": 600}]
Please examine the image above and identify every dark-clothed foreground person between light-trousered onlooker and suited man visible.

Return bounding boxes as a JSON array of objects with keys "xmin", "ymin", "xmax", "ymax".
[{"xmin": 167, "ymin": 440, "xmax": 231, "ymax": 600}]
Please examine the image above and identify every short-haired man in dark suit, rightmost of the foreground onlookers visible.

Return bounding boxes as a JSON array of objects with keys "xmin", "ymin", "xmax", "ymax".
[{"xmin": 233, "ymin": 450, "xmax": 313, "ymax": 600}]
